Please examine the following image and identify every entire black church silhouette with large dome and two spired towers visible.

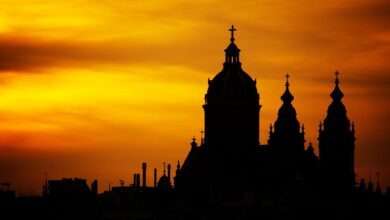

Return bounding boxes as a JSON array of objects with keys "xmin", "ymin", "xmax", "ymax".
[{"xmin": 175, "ymin": 26, "xmax": 355, "ymax": 197}]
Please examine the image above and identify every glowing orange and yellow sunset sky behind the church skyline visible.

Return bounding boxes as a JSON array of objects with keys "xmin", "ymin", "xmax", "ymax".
[{"xmin": 0, "ymin": 0, "xmax": 390, "ymax": 194}]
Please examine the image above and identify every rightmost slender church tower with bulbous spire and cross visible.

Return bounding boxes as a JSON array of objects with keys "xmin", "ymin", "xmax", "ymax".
[{"xmin": 318, "ymin": 72, "xmax": 355, "ymax": 192}]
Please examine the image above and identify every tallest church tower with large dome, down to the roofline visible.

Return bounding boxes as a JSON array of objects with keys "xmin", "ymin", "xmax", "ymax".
[{"xmin": 203, "ymin": 26, "xmax": 261, "ymax": 155}]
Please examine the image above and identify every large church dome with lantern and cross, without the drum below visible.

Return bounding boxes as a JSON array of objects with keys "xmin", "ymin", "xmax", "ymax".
[{"xmin": 206, "ymin": 27, "xmax": 259, "ymax": 100}]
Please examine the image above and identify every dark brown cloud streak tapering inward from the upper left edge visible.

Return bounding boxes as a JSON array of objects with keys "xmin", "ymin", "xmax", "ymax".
[{"xmin": 0, "ymin": 35, "xmax": 128, "ymax": 71}]
